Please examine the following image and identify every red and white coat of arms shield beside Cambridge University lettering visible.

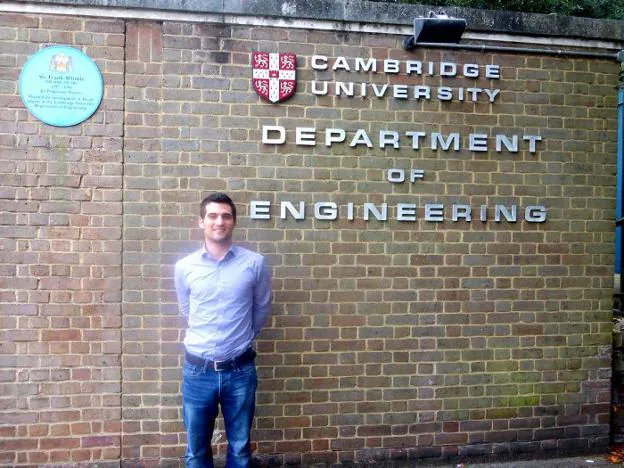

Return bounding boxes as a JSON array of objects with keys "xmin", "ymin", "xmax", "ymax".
[{"xmin": 251, "ymin": 52, "xmax": 297, "ymax": 103}]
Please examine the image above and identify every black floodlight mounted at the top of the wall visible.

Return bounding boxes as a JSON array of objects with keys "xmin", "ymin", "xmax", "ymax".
[{"xmin": 403, "ymin": 11, "xmax": 466, "ymax": 50}]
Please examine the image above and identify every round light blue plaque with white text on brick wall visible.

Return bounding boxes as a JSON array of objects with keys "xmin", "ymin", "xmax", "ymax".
[{"xmin": 19, "ymin": 46, "xmax": 104, "ymax": 127}]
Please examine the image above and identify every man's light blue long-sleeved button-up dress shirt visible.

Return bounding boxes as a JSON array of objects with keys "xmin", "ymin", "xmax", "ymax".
[{"xmin": 175, "ymin": 245, "xmax": 272, "ymax": 361}]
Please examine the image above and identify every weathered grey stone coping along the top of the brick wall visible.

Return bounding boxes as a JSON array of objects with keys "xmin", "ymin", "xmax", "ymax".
[{"xmin": 8, "ymin": 0, "xmax": 624, "ymax": 43}]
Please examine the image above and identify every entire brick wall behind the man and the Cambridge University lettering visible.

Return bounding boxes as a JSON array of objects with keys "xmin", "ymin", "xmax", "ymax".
[{"xmin": 0, "ymin": 6, "xmax": 617, "ymax": 466}]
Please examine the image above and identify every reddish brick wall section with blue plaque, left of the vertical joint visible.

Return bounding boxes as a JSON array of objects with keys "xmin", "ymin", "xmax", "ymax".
[{"xmin": 0, "ymin": 14, "xmax": 125, "ymax": 466}]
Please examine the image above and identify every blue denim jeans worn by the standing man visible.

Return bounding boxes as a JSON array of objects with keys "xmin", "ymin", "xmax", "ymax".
[{"xmin": 182, "ymin": 361, "xmax": 258, "ymax": 468}]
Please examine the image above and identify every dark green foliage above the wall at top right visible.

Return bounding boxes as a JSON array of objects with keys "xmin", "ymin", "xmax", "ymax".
[{"xmin": 401, "ymin": 0, "xmax": 624, "ymax": 20}]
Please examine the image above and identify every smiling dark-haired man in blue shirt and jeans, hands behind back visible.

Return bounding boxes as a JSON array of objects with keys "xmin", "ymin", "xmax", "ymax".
[{"xmin": 175, "ymin": 193, "xmax": 271, "ymax": 468}]
